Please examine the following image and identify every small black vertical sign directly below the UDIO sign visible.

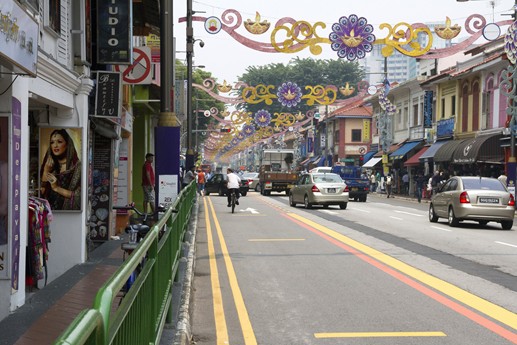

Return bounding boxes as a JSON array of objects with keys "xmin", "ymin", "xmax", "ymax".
[{"xmin": 94, "ymin": 71, "xmax": 122, "ymax": 118}]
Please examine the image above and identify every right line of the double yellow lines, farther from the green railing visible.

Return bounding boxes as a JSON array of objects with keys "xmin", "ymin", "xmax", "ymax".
[{"xmin": 209, "ymin": 196, "xmax": 257, "ymax": 345}]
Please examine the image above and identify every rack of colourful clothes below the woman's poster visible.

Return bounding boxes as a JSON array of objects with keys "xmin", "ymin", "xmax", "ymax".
[{"xmin": 25, "ymin": 197, "xmax": 52, "ymax": 289}]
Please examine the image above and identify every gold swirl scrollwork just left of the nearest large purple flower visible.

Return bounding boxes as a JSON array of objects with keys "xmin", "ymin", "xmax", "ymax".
[{"xmin": 271, "ymin": 20, "xmax": 331, "ymax": 55}]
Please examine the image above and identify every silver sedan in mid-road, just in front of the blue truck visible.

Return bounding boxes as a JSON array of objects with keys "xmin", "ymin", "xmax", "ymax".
[{"xmin": 289, "ymin": 173, "xmax": 349, "ymax": 210}]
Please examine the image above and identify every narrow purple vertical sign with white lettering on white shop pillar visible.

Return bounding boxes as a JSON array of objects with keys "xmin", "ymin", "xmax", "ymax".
[{"xmin": 10, "ymin": 97, "xmax": 22, "ymax": 292}]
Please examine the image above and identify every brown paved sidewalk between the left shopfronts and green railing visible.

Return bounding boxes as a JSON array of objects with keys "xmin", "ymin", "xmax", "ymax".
[{"xmin": 0, "ymin": 236, "xmax": 123, "ymax": 345}]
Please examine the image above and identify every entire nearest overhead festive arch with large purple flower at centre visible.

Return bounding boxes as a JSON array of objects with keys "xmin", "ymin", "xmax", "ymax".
[{"xmin": 180, "ymin": 9, "xmax": 513, "ymax": 61}]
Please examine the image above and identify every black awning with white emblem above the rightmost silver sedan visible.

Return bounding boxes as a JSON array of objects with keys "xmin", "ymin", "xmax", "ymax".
[{"xmin": 452, "ymin": 134, "xmax": 504, "ymax": 164}]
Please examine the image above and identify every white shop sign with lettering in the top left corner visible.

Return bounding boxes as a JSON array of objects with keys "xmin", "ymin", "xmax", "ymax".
[{"xmin": 0, "ymin": 0, "xmax": 39, "ymax": 77}]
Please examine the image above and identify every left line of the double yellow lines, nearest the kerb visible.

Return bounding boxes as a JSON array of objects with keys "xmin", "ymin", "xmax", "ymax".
[{"xmin": 204, "ymin": 203, "xmax": 229, "ymax": 345}]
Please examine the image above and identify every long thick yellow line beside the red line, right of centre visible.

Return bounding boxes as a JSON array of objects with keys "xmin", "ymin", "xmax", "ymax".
[{"xmin": 288, "ymin": 213, "xmax": 517, "ymax": 329}]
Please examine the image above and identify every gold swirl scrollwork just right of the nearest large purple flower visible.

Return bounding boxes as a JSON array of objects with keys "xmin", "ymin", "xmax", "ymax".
[{"xmin": 374, "ymin": 22, "xmax": 433, "ymax": 57}]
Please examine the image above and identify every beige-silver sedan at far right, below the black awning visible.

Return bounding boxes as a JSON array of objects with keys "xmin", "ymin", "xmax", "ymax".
[{"xmin": 429, "ymin": 176, "xmax": 515, "ymax": 230}]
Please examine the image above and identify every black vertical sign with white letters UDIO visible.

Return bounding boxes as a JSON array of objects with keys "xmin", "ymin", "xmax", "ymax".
[{"xmin": 97, "ymin": 0, "xmax": 133, "ymax": 64}]
